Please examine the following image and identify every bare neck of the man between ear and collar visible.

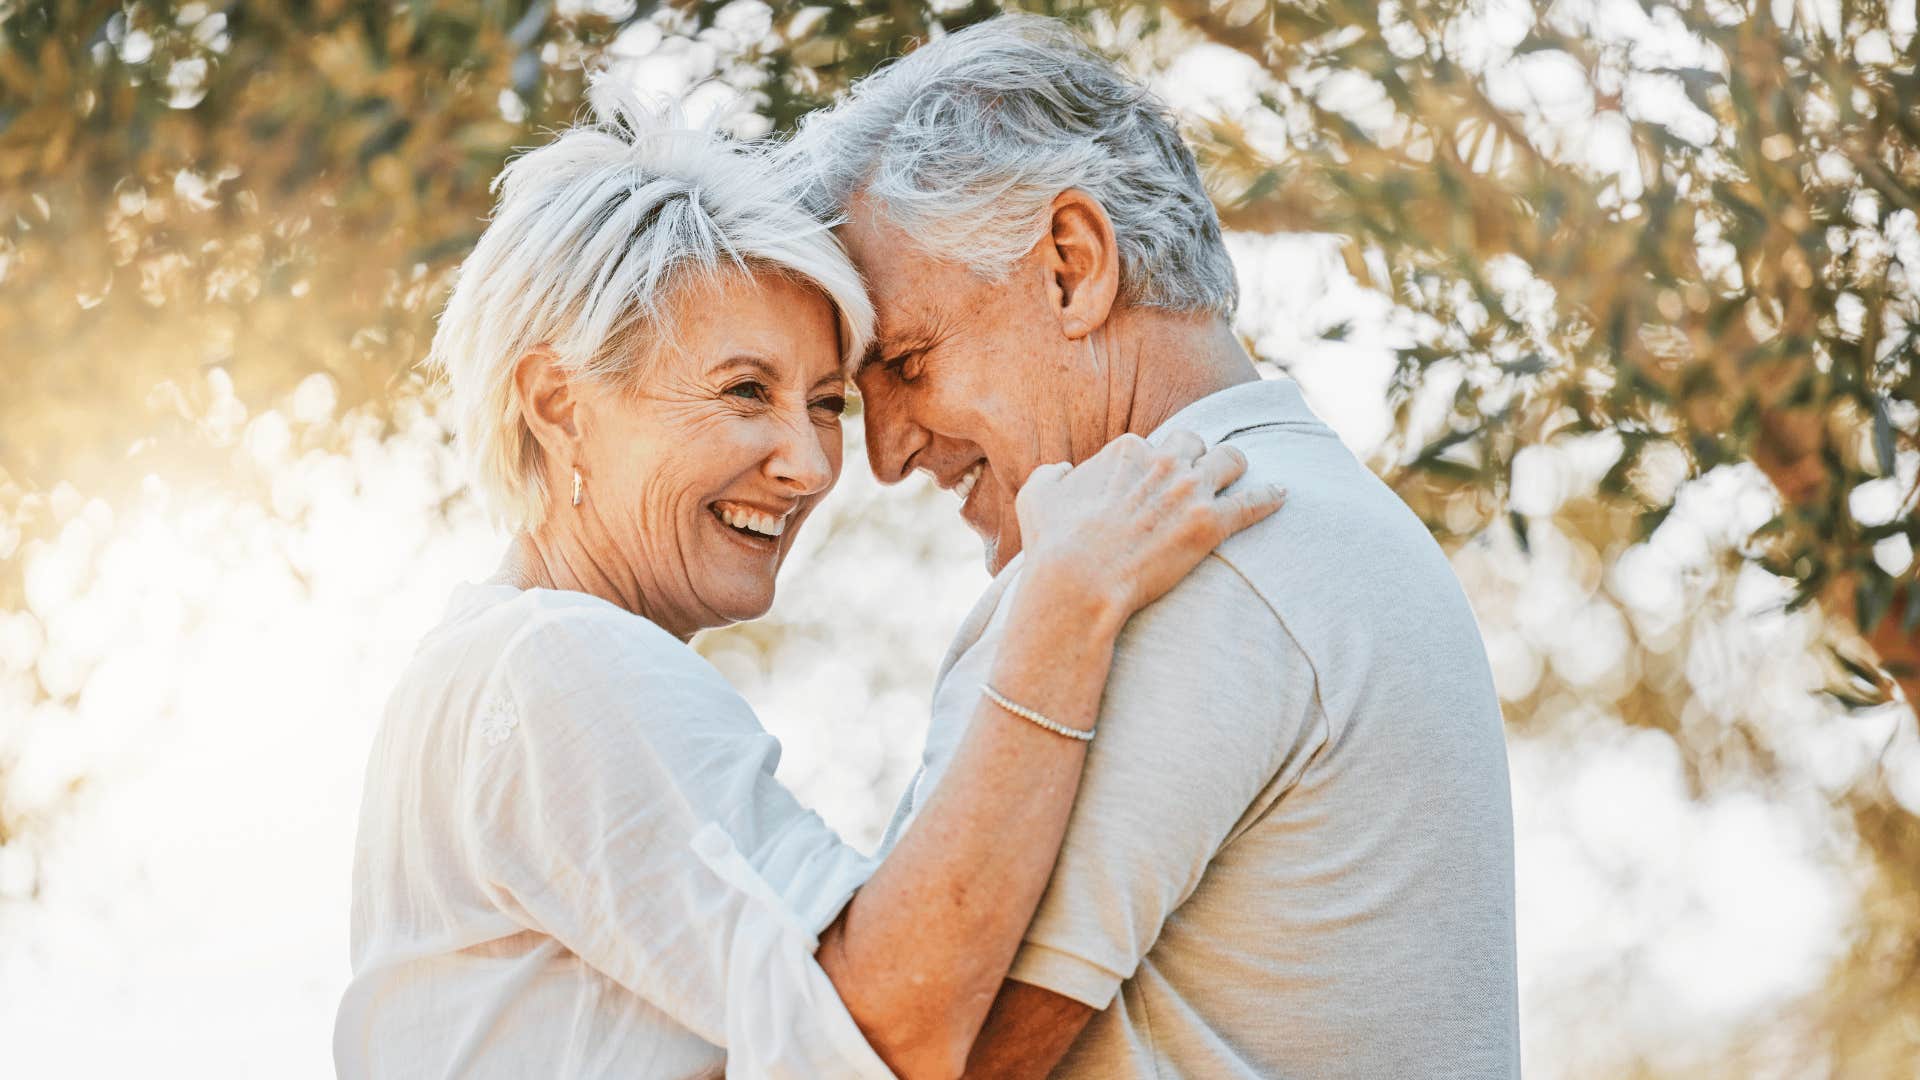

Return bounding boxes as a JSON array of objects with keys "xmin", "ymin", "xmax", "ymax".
[{"xmin": 1094, "ymin": 307, "xmax": 1260, "ymax": 438}]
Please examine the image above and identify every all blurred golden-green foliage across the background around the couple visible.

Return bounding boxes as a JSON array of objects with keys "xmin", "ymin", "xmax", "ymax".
[{"xmin": 0, "ymin": 0, "xmax": 1920, "ymax": 1070}]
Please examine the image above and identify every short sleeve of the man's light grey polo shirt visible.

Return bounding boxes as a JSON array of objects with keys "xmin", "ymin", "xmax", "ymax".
[{"xmin": 1010, "ymin": 555, "xmax": 1327, "ymax": 1009}]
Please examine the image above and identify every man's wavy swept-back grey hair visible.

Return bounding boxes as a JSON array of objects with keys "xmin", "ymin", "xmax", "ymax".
[{"xmin": 783, "ymin": 13, "xmax": 1238, "ymax": 319}]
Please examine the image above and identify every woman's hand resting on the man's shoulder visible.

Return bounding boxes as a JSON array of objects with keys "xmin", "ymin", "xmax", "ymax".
[{"xmin": 1014, "ymin": 430, "xmax": 1286, "ymax": 623}]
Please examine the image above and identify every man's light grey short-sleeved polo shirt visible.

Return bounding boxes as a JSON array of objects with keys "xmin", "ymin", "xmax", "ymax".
[{"xmin": 885, "ymin": 380, "xmax": 1519, "ymax": 1080}]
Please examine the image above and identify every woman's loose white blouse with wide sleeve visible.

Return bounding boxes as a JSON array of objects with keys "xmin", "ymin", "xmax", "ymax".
[{"xmin": 334, "ymin": 586, "xmax": 891, "ymax": 1078}]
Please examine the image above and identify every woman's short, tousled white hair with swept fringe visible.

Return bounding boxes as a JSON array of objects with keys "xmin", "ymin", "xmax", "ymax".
[{"xmin": 428, "ymin": 73, "xmax": 874, "ymax": 528}]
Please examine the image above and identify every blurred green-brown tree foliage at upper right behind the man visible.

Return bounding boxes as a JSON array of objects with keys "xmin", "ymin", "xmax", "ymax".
[{"xmin": 1169, "ymin": 2, "xmax": 1920, "ymax": 703}]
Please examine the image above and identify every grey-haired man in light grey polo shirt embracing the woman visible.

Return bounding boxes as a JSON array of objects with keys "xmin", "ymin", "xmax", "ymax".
[{"xmin": 787, "ymin": 17, "xmax": 1519, "ymax": 1078}]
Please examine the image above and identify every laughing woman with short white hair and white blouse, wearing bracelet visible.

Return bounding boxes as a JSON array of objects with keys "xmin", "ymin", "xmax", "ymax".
[{"xmin": 334, "ymin": 81, "xmax": 1279, "ymax": 1078}]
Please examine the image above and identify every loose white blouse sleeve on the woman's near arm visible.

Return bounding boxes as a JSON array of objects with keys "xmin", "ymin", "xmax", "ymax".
[{"xmin": 463, "ymin": 609, "xmax": 891, "ymax": 1078}]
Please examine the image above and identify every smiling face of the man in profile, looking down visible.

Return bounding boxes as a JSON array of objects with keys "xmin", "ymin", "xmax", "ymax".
[{"xmin": 839, "ymin": 200, "xmax": 1106, "ymax": 573}]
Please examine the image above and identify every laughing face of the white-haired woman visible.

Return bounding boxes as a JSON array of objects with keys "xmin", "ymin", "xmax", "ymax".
[{"xmin": 553, "ymin": 271, "xmax": 847, "ymax": 636}]
